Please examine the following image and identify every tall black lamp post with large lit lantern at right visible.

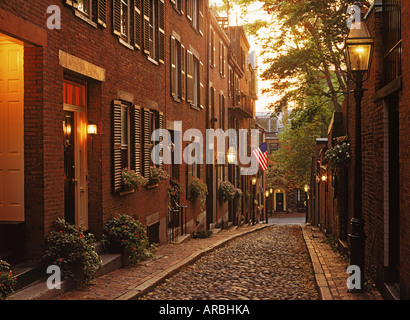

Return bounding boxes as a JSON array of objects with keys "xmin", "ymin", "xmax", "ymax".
[{"xmin": 345, "ymin": 2, "xmax": 374, "ymax": 292}]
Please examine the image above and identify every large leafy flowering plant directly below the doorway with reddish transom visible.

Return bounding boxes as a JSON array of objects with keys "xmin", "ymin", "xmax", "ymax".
[{"xmin": 43, "ymin": 218, "xmax": 102, "ymax": 284}]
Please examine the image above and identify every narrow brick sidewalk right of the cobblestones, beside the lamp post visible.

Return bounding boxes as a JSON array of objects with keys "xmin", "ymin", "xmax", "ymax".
[{"xmin": 302, "ymin": 226, "xmax": 383, "ymax": 300}]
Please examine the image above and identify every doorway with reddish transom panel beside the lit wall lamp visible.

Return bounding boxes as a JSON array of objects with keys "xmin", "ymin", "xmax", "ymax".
[{"xmin": 63, "ymin": 80, "xmax": 88, "ymax": 230}]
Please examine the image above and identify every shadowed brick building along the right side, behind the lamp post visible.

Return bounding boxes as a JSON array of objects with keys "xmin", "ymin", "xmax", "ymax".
[{"xmin": 309, "ymin": 0, "xmax": 410, "ymax": 299}]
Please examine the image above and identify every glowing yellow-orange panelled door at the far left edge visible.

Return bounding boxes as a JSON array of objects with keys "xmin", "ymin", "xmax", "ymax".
[{"xmin": 0, "ymin": 34, "xmax": 24, "ymax": 221}]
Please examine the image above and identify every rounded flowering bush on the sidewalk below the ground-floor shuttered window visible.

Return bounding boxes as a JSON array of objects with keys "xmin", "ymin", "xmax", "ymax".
[{"xmin": 101, "ymin": 213, "xmax": 152, "ymax": 265}]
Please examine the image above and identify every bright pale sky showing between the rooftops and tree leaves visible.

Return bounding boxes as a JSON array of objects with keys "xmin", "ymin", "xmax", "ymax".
[{"xmin": 209, "ymin": 0, "xmax": 274, "ymax": 112}]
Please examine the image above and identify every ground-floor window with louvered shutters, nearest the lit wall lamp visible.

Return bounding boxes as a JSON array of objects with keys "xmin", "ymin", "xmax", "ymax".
[{"xmin": 113, "ymin": 100, "xmax": 163, "ymax": 192}]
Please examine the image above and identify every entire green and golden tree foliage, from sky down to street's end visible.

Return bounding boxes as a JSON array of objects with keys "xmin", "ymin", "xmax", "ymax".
[{"xmin": 231, "ymin": 0, "xmax": 362, "ymax": 188}]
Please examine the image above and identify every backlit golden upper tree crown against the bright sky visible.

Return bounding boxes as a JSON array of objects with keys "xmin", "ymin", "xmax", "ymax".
[{"xmin": 238, "ymin": 0, "xmax": 358, "ymax": 111}]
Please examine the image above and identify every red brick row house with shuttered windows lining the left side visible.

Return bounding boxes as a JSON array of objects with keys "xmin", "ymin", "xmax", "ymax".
[{"xmin": 0, "ymin": 0, "xmax": 260, "ymax": 263}]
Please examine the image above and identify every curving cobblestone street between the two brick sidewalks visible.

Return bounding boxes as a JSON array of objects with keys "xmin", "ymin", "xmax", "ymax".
[{"xmin": 140, "ymin": 225, "xmax": 318, "ymax": 300}]
